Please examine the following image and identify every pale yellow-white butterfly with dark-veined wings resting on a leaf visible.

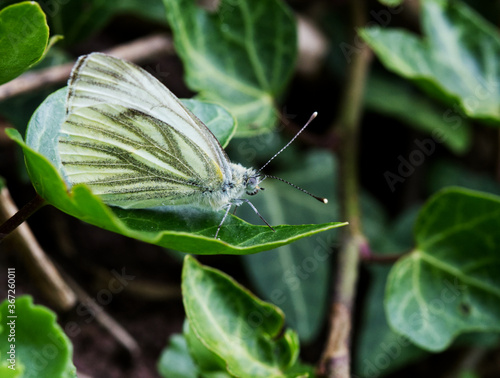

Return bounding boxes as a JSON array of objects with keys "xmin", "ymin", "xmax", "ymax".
[{"xmin": 58, "ymin": 53, "xmax": 327, "ymax": 238}]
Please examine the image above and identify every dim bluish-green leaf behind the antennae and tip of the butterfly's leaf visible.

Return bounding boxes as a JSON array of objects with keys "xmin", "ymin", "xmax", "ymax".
[{"xmin": 238, "ymin": 151, "xmax": 339, "ymax": 342}]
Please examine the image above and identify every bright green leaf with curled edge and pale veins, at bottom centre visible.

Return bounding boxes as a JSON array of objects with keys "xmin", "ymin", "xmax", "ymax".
[{"xmin": 182, "ymin": 255, "xmax": 307, "ymax": 377}]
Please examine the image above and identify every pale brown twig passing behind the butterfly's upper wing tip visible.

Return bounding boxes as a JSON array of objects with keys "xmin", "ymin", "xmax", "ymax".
[{"xmin": 0, "ymin": 34, "xmax": 174, "ymax": 101}]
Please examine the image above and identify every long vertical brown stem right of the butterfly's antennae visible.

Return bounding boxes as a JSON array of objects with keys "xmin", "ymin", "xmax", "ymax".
[{"xmin": 318, "ymin": 0, "xmax": 371, "ymax": 378}]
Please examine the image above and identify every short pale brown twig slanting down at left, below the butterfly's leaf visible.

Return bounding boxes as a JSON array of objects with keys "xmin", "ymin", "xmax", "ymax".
[{"xmin": 0, "ymin": 188, "xmax": 76, "ymax": 311}]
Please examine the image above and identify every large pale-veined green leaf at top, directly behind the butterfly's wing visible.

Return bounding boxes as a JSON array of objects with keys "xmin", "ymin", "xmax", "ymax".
[{"xmin": 164, "ymin": 0, "xmax": 297, "ymax": 136}]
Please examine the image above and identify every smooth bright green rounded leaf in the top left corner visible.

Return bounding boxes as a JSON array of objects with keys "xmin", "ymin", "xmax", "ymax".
[{"xmin": 0, "ymin": 1, "xmax": 49, "ymax": 85}]
